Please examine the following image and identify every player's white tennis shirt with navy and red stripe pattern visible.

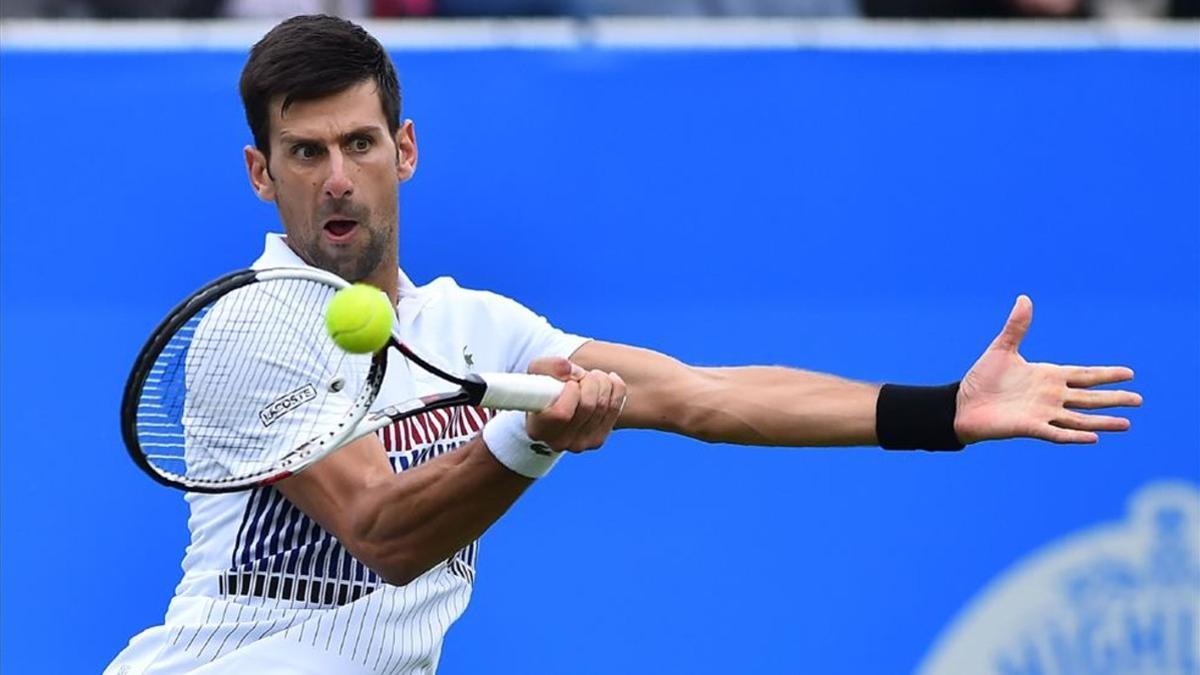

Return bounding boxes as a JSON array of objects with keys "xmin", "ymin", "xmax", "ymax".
[{"xmin": 104, "ymin": 234, "xmax": 587, "ymax": 675}]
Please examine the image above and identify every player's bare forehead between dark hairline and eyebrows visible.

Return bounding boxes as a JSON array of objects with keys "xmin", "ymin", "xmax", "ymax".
[{"xmin": 271, "ymin": 82, "xmax": 388, "ymax": 138}]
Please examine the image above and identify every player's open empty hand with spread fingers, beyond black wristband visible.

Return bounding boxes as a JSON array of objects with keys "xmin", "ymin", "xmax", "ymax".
[{"xmin": 954, "ymin": 295, "xmax": 1141, "ymax": 443}]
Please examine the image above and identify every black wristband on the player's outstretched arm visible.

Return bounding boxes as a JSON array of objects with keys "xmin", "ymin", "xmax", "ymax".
[{"xmin": 875, "ymin": 382, "xmax": 964, "ymax": 450}]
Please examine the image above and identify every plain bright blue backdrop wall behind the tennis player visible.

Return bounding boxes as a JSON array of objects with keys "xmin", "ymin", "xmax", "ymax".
[{"xmin": 0, "ymin": 42, "xmax": 1200, "ymax": 675}]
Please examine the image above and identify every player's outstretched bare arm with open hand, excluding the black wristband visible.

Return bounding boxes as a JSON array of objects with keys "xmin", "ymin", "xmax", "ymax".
[{"xmin": 571, "ymin": 295, "xmax": 1141, "ymax": 447}]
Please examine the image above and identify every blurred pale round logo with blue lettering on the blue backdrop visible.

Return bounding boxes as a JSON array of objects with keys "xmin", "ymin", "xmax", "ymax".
[{"xmin": 917, "ymin": 482, "xmax": 1200, "ymax": 675}]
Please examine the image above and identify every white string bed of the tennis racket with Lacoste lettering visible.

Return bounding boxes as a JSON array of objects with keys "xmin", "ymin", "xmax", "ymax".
[{"xmin": 137, "ymin": 279, "xmax": 370, "ymax": 484}]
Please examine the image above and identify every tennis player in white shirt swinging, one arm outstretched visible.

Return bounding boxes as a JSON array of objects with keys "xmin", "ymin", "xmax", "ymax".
[{"xmin": 107, "ymin": 16, "xmax": 1141, "ymax": 675}]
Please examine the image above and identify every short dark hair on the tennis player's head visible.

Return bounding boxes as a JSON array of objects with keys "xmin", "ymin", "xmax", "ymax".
[{"xmin": 239, "ymin": 14, "xmax": 400, "ymax": 155}]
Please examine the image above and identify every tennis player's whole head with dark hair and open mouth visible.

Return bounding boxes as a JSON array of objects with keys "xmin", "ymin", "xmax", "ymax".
[{"xmin": 241, "ymin": 16, "xmax": 416, "ymax": 286}]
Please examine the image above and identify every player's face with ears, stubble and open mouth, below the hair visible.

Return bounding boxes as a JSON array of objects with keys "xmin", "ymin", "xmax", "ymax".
[{"xmin": 246, "ymin": 80, "xmax": 416, "ymax": 281}]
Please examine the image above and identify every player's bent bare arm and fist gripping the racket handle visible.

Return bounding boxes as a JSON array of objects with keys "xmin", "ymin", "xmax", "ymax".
[{"xmin": 276, "ymin": 359, "xmax": 624, "ymax": 585}]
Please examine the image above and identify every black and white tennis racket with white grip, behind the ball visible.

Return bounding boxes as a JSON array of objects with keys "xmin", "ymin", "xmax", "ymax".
[{"xmin": 121, "ymin": 268, "xmax": 563, "ymax": 492}]
